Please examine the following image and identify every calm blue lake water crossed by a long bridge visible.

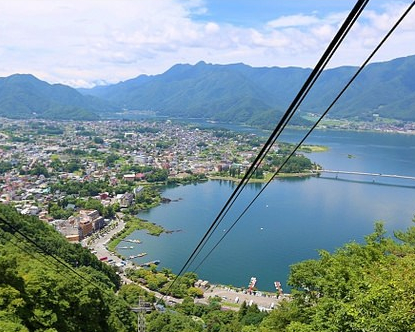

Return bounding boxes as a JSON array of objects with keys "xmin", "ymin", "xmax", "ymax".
[{"xmin": 119, "ymin": 131, "xmax": 415, "ymax": 290}]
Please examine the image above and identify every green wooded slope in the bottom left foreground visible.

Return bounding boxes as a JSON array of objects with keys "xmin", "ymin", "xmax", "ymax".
[{"xmin": 0, "ymin": 205, "xmax": 136, "ymax": 332}]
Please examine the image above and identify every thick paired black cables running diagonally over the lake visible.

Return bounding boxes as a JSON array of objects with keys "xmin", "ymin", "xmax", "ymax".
[{"xmin": 159, "ymin": 0, "xmax": 369, "ymax": 302}]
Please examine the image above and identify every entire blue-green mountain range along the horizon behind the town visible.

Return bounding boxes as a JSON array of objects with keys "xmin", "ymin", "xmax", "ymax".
[{"xmin": 0, "ymin": 56, "xmax": 415, "ymax": 126}]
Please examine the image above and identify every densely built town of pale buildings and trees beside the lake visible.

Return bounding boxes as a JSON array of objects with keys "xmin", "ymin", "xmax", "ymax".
[{"xmin": 0, "ymin": 119, "xmax": 311, "ymax": 242}]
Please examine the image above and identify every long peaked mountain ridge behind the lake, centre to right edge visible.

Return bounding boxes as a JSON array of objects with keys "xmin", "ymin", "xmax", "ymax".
[{"xmin": 82, "ymin": 56, "xmax": 415, "ymax": 125}]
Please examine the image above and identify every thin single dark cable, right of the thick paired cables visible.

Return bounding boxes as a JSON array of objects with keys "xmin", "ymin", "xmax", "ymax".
[{"xmin": 193, "ymin": 0, "xmax": 415, "ymax": 272}]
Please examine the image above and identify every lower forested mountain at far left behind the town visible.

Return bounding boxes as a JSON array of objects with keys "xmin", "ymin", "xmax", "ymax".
[{"xmin": 0, "ymin": 74, "xmax": 110, "ymax": 120}]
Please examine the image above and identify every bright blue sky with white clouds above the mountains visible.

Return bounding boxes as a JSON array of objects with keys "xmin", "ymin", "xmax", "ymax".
[{"xmin": 0, "ymin": 0, "xmax": 415, "ymax": 87}]
